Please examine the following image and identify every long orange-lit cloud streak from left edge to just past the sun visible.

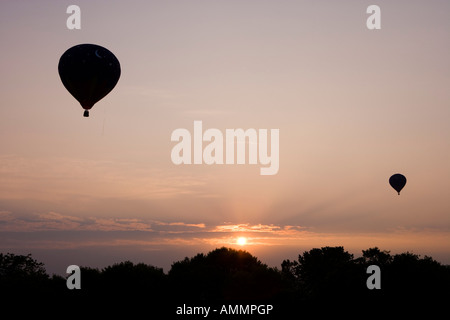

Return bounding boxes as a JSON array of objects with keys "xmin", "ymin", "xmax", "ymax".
[{"xmin": 0, "ymin": 211, "xmax": 306, "ymax": 247}]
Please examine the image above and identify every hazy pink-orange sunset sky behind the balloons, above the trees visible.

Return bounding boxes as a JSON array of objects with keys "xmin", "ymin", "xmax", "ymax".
[{"xmin": 0, "ymin": 0, "xmax": 450, "ymax": 274}]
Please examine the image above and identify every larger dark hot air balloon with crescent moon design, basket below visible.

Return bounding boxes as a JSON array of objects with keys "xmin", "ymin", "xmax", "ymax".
[{"xmin": 58, "ymin": 44, "xmax": 120, "ymax": 117}]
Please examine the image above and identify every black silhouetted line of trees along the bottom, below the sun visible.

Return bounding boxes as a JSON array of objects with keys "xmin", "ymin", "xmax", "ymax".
[{"xmin": 0, "ymin": 247, "xmax": 450, "ymax": 318}]
